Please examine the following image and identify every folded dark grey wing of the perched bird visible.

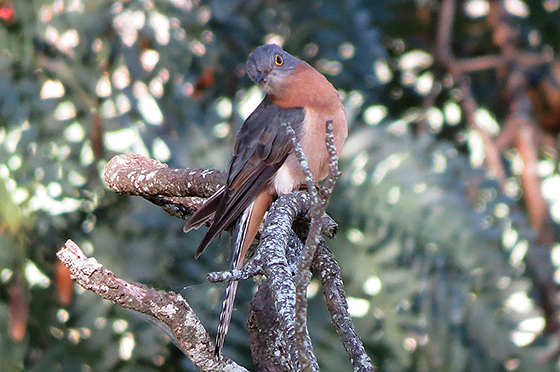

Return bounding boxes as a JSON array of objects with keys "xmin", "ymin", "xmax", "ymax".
[{"xmin": 191, "ymin": 96, "xmax": 305, "ymax": 257}]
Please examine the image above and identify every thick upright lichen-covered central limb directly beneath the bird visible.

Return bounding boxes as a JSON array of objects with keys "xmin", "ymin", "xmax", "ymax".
[{"xmin": 241, "ymin": 191, "xmax": 344, "ymax": 371}]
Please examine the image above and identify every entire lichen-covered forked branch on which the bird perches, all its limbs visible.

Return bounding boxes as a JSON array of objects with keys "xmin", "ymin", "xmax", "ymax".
[{"xmin": 57, "ymin": 122, "xmax": 374, "ymax": 371}]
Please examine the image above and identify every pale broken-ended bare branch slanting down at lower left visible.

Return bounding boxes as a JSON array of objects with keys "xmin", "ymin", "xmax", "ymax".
[{"xmin": 57, "ymin": 240, "xmax": 247, "ymax": 372}]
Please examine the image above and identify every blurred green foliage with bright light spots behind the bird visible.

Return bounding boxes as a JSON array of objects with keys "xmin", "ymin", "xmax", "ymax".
[{"xmin": 0, "ymin": 0, "xmax": 560, "ymax": 372}]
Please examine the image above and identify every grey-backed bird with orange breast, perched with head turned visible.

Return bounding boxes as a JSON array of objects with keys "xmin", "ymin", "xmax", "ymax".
[{"xmin": 184, "ymin": 44, "xmax": 348, "ymax": 357}]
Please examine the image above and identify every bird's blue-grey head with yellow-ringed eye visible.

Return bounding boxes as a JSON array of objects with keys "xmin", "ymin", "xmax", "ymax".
[{"xmin": 245, "ymin": 44, "xmax": 303, "ymax": 93}]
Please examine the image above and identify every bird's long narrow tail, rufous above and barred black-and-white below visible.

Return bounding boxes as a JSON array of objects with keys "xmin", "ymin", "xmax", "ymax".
[{"xmin": 216, "ymin": 192, "xmax": 273, "ymax": 357}]
